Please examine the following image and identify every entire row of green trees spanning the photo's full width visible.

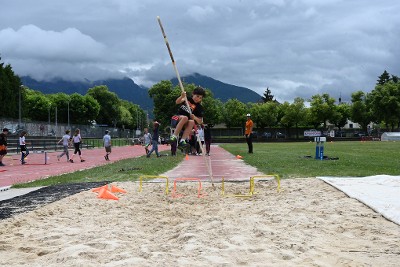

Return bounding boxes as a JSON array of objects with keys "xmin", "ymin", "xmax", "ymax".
[{"xmin": 0, "ymin": 58, "xmax": 400, "ymax": 136}]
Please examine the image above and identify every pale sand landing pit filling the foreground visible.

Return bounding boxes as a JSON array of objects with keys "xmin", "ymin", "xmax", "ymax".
[{"xmin": 0, "ymin": 179, "xmax": 400, "ymax": 266}]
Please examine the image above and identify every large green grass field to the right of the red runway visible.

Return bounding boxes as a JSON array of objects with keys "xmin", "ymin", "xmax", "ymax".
[{"xmin": 221, "ymin": 141, "xmax": 400, "ymax": 178}]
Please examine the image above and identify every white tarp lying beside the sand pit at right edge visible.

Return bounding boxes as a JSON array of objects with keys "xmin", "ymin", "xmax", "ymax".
[{"xmin": 317, "ymin": 175, "xmax": 400, "ymax": 225}]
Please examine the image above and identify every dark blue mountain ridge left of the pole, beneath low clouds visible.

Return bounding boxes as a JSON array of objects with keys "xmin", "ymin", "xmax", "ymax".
[{"xmin": 21, "ymin": 76, "xmax": 153, "ymax": 110}]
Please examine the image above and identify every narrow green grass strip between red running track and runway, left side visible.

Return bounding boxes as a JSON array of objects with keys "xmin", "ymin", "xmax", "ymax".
[{"xmin": 13, "ymin": 152, "xmax": 184, "ymax": 188}]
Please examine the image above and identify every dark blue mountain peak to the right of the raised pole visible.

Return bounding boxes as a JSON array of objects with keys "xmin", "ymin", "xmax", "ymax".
[{"xmin": 171, "ymin": 73, "xmax": 261, "ymax": 103}]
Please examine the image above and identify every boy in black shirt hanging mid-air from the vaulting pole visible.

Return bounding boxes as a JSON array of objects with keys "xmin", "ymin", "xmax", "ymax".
[{"xmin": 170, "ymin": 86, "xmax": 206, "ymax": 150}]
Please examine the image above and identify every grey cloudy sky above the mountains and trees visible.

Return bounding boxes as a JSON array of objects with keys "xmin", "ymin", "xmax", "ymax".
[{"xmin": 0, "ymin": 0, "xmax": 400, "ymax": 102}]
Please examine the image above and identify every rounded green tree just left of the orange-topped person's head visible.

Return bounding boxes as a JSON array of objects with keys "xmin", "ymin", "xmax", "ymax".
[{"xmin": 223, "ymin": 98, "xmax": 246, "ymax": 128}]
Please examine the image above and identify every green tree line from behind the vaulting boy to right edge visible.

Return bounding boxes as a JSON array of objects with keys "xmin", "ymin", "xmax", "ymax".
[{"xmin": 149, "ymin": 70, "xmax": 400, "ymax": 136}]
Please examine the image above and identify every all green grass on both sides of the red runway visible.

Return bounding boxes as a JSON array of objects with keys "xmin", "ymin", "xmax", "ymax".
[{"xmin": 14, "ymin": 141, "xmax": 400, "ymax": 187}]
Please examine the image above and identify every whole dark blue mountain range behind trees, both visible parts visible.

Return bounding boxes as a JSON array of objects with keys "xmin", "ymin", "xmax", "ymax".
[{"xmin": 21, "ymin": 73, "xmax": 261, "ymax": 112}]
